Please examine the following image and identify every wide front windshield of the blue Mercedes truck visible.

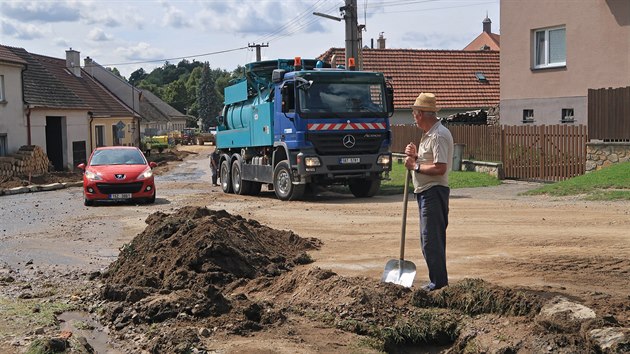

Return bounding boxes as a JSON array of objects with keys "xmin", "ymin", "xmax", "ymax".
[{"xmin": 298, "ymin": 80, "xmax": 387, "ymax": 118}]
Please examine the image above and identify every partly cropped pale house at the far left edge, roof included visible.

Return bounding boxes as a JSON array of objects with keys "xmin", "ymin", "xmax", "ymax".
[{"xmin": 0, "ymin": 46, "xmax": 28, "ymax": 156}]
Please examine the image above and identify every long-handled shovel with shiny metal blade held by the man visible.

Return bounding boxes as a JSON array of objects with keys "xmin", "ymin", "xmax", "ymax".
[{"xmin": 381, "ymin": 170, "xmax": 416, "ymax": 288}]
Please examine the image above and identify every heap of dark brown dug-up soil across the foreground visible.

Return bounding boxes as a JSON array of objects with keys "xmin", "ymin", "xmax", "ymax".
[{"xmin": 101, "ymin": 207, "xmax": 628, "ymax": 353}]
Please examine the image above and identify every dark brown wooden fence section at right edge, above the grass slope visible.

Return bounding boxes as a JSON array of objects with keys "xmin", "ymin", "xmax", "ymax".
[{"xmin": 588, "ymin": 86, "xmax": 630, "ymax": 141}]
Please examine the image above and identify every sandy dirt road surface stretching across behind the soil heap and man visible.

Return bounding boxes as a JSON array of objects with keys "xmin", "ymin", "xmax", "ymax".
[{"xmin": 0, "ymin": 146, "xmax": 630, "ymax": 352}]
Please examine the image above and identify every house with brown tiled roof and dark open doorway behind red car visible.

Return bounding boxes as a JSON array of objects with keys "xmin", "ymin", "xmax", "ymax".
[{"xmin": 0, "ymin": 46, "xmax": 138, "ymax": 170}]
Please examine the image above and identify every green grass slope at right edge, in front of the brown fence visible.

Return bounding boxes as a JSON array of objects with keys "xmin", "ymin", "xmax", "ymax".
[{"xmin": 522, "ymin": 162, "xmax": 630, "ymax": 200}]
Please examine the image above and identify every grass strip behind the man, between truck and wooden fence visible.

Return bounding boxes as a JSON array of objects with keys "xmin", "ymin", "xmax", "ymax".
[{"xmin": 379, "ymin": 161, "xmax": 501, "ymax": 195}]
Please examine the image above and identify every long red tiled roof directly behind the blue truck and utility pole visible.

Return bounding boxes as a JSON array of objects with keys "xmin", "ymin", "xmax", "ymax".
[{"xmin": 319, "ymin": 48, "xmax": 499, "ymax": 109}]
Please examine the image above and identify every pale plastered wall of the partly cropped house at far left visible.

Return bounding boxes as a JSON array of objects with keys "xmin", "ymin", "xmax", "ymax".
[{"xmin": 0, "ymin": 63, "xmax": 28, "ymax": 154}]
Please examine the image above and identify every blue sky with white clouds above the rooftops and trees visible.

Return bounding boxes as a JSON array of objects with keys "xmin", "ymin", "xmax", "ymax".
[{"xmin": 0, "ymin": 0, "xmax": 500, "ymax": 77}]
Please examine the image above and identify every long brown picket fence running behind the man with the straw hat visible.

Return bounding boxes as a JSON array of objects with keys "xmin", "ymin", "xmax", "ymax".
[{"xmin": 392, "ymin": 125, "xmax": 588, "ymax": 181}]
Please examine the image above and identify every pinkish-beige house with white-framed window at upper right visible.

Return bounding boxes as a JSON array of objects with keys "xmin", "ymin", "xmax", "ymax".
[{"xmin": 500, "ymin": 0, "xmax": 630, "ymax": 125}]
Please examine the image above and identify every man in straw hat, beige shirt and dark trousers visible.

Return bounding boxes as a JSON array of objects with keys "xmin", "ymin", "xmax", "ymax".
[{"xmin": 405, "ymin": 93, "xmax": 454, "ymax": 291}]
